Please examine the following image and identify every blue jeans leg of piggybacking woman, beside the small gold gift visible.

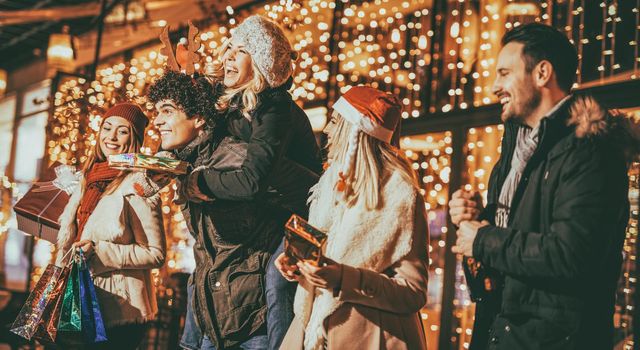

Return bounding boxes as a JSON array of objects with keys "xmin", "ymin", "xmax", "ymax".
[{"xmin": 266, "ymin": 240, "xmax": 297, "ymax": 350}]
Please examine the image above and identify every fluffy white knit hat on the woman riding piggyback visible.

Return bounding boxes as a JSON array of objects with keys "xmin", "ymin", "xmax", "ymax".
[{"xmin": 233, "ymin": 15, "xmax": 295, "ymax": 88}]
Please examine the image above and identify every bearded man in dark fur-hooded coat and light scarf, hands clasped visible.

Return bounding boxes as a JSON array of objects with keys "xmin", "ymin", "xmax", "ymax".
[{"xmin": 450, "ymin": 23, "xmax": 629, "ymax": 349}]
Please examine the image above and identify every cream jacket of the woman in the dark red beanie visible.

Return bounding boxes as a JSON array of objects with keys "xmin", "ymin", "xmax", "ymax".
[{"xmin": 56, "ymin": 173, "xmax": 166, "ymax": 328}]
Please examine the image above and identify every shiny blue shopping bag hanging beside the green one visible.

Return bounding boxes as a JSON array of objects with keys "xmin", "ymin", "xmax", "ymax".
[{"xmin": 78, "ymin": 251, "xmax": 107, "ymax": 344}]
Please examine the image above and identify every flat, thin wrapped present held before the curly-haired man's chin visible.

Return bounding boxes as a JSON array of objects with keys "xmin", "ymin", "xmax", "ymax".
[{"xmin": 109, "ymin": 153, "xmax": 189, "ymax": 175}]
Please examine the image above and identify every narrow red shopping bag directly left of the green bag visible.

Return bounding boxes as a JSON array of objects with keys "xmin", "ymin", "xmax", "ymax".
[{"xmin": 33, "ymin": 265, "xmax": 71, "ymax": 343}]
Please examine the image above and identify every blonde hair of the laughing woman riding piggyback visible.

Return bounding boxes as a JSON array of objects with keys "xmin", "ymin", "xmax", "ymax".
[{"xmin": 207, "ymin": 40, "xmax": 269, "ymax": 120}]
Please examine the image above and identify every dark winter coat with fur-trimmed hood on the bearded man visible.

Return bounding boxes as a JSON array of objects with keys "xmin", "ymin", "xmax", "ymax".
[{"xmin": 472, "ymin": 97, "xmax": 629, "ymax": 350}]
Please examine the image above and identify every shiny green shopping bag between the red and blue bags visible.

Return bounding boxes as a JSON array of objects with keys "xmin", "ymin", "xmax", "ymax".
[{"xmin": 58, "ymin": 254, "xmax": 82, "ymax": 332}]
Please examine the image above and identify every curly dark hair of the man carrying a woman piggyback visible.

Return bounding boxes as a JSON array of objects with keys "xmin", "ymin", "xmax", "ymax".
[{"xmin": 148, "ymin": 71, "xmax": 222, "ymax": 126}]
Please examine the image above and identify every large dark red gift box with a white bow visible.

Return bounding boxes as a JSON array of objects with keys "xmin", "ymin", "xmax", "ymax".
[{"xmin": 13, "ymin": 163, "xmax": 81, "ymax": 243}]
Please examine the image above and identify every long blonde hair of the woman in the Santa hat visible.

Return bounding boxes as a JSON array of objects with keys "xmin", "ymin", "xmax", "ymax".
[{"xmin": 327, "ymin": 111, "xmax": 418, "ymax": 210}]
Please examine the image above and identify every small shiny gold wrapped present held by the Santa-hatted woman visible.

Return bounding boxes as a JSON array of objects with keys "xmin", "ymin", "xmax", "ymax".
[{"xmin": 284, "ymin": 214, "xmax": 327, "ymax": 266}]
